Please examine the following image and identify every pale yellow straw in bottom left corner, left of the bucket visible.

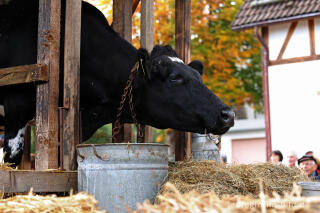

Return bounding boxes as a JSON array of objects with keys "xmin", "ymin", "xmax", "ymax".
[{"xmin": 0, "ymin": 192, "xmax": 105, "ymax": 213}]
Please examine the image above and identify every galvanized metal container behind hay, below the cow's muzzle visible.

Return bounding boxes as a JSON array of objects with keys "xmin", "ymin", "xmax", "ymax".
[{"xmin": 191, "ymin": 133, "xmax": 220, "ymax": 162}]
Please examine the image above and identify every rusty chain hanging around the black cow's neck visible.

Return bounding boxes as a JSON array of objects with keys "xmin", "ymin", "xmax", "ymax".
[{"xmin": 112, "ymin": 59, "xmax": 145, "ymax": 143}]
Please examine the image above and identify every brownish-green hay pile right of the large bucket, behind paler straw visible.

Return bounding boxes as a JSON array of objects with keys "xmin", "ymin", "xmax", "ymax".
[{"xmin": 164, "ymin": 161, "xmax": 307, "ymax": 197}]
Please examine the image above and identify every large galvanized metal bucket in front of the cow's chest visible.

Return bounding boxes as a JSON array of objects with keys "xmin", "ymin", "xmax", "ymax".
[{"xmin": 77, "ymin": 143, "xmax": 168, "ymax": 213}]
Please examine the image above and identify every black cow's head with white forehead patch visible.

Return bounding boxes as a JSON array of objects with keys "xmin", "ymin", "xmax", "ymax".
[{"xmin": 134, "ymin": 46, "xmax": 234, "ymax": 135}]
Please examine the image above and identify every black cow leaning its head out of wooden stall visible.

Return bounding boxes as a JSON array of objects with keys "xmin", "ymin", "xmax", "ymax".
[{"xmin": 0, "ymin": 0, "xmax": 234, "ymax": 164}]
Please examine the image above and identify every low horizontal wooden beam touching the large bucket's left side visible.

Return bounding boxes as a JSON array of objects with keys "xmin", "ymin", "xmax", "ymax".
[{"xmin": 0, "ymin": 170, "xmax": 78, "ymax": 193}]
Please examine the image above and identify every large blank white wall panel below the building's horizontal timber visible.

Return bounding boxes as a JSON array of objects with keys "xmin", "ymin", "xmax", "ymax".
[{"xmin": 269, "ymin": 60, "xmax": 320, "ymax": 161}]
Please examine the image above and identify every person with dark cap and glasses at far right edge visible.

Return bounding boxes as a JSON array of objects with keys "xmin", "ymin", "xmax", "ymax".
[{"xmin": 298, "ymin": 155, "xmax": 320, "ymax": 180}]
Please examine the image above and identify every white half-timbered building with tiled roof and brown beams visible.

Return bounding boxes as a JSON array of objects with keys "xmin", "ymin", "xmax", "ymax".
[{"xmin": 232, "ymin": 0, "xmax": 320, "ymax": 161}]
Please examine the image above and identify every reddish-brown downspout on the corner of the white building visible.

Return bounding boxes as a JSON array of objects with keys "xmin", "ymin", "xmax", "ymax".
[{"xmin": 254, "ymin": 27, "xmax": 271, "ymax": 161}]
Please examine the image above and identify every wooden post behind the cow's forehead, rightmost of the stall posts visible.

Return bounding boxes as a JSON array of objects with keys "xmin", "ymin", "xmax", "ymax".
[{"xmin": 174, "ymin": 0, "xmax": 191, "ymax": 161}]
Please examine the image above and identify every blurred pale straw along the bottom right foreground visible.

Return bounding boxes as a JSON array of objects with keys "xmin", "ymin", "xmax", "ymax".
[{"xmin": 134, "ymin": 183, "xmax": 320, "ymax": 213}]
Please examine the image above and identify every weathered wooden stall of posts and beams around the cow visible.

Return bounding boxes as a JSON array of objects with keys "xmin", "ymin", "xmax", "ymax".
[{"xmin": 0, "ymin": 0, "xmax": 191, "ymax": 193}]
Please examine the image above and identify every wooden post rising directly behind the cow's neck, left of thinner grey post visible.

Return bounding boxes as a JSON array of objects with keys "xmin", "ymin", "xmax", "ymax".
[{"xmin": 112, "ymin": 0, "xmax": 132, "ymax": 142}]
